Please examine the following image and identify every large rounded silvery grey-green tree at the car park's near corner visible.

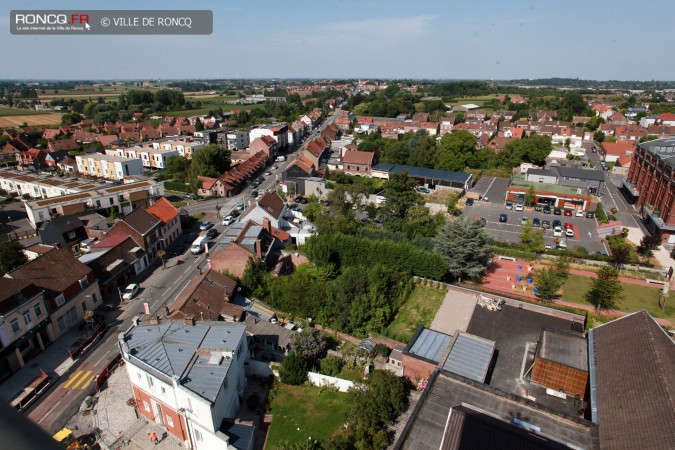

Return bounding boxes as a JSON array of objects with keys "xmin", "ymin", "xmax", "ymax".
[{"xmin": 434, "ymin": 218, "xmax": 493, "ymax": 282}]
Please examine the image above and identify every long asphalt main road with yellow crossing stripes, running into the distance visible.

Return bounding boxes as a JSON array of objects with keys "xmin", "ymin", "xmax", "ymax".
[{"xmin": 26, "ymin": 110, "xmax": 336, "ymax": 434}]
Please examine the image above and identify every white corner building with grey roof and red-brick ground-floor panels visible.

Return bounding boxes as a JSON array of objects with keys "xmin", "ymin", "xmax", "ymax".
[{"xmin": 119, "ymin": 319, "xmax": 253, "ymax": 450}]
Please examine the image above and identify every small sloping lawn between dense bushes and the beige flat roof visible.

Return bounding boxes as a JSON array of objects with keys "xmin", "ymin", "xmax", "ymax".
[{"xmin": 387, "ymin": 285, "xmax": 447, "ymax": 342}]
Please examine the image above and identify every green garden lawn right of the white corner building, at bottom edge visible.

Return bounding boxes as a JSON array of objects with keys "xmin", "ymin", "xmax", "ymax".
[{"xmin": 267, "ymin": 384, "xmax": 350, "ymax": 449}]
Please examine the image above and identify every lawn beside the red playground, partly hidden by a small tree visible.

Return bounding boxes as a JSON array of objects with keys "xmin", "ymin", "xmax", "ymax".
[{"xmin": 562, "ymin": 275, "xmax": 675, "ymax": 319}]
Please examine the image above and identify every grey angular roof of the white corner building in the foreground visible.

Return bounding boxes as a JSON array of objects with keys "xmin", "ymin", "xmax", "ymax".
[{"xmin": 124, "ymin": 322, "xmax": 246, "ymax": 402}]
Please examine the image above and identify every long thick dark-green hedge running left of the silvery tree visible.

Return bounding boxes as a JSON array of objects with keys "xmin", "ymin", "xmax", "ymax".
[{"xmin": 305, "ymin": 234, "xmax": 447, "ymax": 280}]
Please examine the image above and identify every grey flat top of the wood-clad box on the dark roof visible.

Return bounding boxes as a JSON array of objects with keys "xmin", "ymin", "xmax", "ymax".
[{"xmin": 538, "ymin": 329, "xmax": 588, "ymax": 372}]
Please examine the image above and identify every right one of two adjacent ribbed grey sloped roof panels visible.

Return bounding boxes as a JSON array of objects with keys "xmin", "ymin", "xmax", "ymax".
[{"xmin": 443, "ymin": 333, "xmax": 495, "ymax": 383}]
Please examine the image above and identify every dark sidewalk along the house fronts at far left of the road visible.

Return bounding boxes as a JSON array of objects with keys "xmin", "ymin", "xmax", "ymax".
[{"xmin": 0, "ymin": 327, "xmax": 84, "ymax": 401}]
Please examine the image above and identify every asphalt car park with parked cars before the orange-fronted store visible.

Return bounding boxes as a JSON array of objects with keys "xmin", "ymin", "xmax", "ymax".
[{"xmin": 464, "ymin": 201, "xmax": 608, "ymax": 253}]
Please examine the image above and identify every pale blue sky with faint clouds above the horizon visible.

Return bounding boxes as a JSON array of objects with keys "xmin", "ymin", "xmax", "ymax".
[{"xmin": 0, "ymin": 0, "xmax": 675, "ymax": 80}]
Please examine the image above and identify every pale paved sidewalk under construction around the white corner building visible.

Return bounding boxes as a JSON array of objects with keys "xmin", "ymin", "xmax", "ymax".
[{"xmin": 93, "ymin": 366, "xmax": 184, "ymax": 450}]
